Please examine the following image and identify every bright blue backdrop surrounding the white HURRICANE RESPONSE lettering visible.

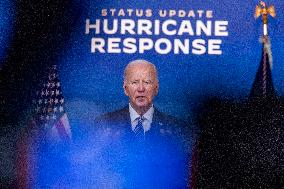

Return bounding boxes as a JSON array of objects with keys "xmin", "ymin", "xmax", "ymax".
[{"xmin": 56, "ymin": 0, "xmax": 284, "ymax": 124}]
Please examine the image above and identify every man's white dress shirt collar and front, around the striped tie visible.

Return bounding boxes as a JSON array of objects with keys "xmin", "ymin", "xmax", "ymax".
[{"xmin": 129, "ymin": 103, "xmax": 154, "ymax": 133}]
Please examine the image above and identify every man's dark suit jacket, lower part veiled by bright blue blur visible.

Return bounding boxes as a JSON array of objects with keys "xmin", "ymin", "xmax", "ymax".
[{"xmin": 91, "ymin": 106, "xmax": 194, "ymax": 188}]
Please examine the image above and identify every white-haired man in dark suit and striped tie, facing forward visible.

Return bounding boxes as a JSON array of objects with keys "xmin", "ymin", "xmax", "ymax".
[{"xmin": 91, "ymin": 60, "xmax": 193, "ymax": 188}]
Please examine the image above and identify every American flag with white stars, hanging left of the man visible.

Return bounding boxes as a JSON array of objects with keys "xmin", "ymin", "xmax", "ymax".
[{"xmin": 33, "ymin": 65, "xmax": 72, "ymax": 141}]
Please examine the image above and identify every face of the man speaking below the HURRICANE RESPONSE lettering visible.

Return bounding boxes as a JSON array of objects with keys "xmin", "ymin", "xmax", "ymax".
[{"xmin": 123, "ymin": 63, "xmax": 159, "ymax": 114}]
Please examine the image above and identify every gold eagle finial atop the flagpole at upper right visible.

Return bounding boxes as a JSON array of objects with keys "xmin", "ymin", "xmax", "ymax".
[{"xmin": 254, "ymin": 1, "xmax": 276, "ymax": 35}]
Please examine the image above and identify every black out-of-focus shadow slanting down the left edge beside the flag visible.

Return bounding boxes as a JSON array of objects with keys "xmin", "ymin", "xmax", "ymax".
[{"xmin": 0, "ymin": 0, "xmax": 76, "ymax": 188}]
